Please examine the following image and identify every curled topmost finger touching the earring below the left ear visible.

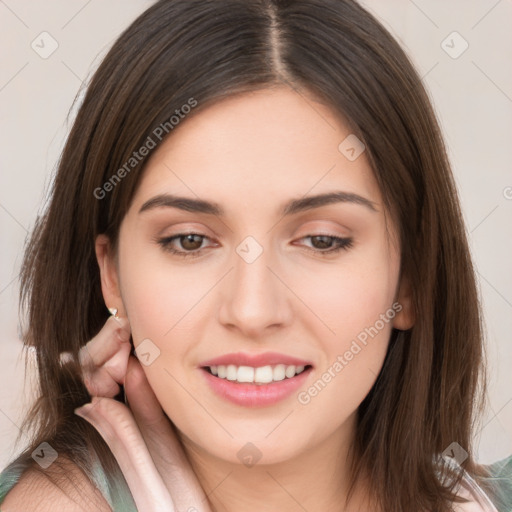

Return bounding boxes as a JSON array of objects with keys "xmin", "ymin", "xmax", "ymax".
[{"xmin": 79, "ymin": 316, "xmax": 130, "ymax": 367}]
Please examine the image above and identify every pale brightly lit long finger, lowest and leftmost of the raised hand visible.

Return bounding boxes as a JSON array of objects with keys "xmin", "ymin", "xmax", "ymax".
[{"xmin": 75, "ymin": 398, "xmax": 175, "ymax": 512}]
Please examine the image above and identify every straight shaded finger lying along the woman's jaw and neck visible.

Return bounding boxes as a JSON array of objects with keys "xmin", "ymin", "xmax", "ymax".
[{"xmin": 125, "ymin": 357, "xmax": 210, "ymax": 512}]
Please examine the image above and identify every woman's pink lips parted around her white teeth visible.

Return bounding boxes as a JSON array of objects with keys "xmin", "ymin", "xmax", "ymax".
[{"xmin": 200, "ymin": 352, "xmax": 312, "ymax": 407}]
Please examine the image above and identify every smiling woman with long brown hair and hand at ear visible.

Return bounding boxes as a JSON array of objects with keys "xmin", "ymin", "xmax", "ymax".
[{"xmin": 1, "ymin": 0, "xmax": 512, "ymax": 512}]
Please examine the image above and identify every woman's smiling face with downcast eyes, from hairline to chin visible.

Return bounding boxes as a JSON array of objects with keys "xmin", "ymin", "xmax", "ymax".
[{"xmin": 98, "ymin": 88, "xmax": 411, "ymax": 464}]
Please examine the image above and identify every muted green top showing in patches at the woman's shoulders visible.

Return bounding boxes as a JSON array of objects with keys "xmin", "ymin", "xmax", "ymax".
[{"xmin": 0, "ymin": 455, "xmax": 512, "ymax": 512}]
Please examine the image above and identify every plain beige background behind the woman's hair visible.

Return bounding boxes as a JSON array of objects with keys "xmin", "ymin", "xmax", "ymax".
[{"xmin": 0, "ymin": 0, "xmax": 512, "ymax": 467}]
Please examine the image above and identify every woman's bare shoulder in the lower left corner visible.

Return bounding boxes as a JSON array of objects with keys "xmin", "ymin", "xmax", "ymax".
[{"xmin": 0, "ymin": 457, "xmax": 112, "ymax": 512}]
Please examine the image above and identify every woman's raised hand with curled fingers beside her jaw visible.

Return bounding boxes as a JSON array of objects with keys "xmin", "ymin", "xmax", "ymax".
[{"xmin": 75, "ymin": 317, "xmax": 210, "ymax": 512}]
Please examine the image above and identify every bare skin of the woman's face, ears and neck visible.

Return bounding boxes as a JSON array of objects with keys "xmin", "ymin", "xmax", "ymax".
[{"xmin": 96, "ymin": 87, "xmax": 414, "ymax": 512}]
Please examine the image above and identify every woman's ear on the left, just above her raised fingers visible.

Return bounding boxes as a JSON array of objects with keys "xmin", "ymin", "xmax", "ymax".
[{"xmin": 95, "ymin": 234, "xmax": 126, "ymax": 317}]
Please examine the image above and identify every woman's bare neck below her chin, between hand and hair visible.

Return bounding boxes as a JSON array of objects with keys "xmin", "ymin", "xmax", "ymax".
[{"xmin": 180, "ymin": 416, "xmax": 377, "ymax": 512}]
